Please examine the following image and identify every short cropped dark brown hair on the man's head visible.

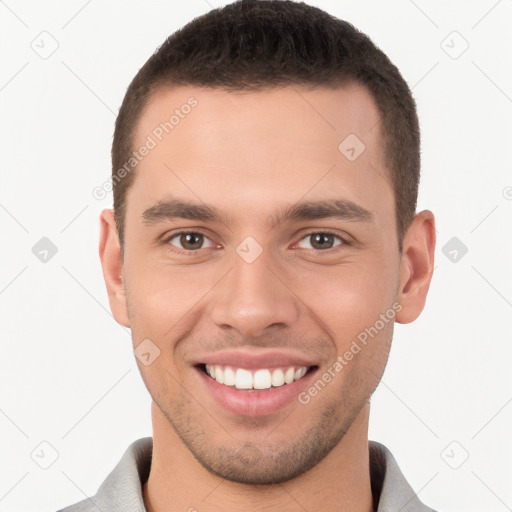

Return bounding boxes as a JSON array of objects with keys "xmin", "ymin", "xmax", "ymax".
[{"xmin": 112, "ymin": 0, "xmax": 420, "ymax": 250}]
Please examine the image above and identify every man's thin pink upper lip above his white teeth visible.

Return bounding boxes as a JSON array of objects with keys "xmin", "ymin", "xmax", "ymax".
[{"xmin": 195, "ymin": 350, "xmax": 315, "ymax": 370}]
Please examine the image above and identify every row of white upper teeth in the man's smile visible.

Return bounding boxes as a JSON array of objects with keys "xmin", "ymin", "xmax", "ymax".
[{"xmin": 206, "ymin": 364, "xmax": 308, "ymax": 389}]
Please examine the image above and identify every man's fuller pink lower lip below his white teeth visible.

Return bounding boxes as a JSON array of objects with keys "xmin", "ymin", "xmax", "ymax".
[{"xmin": 196, "ymin": 368, "xmax": 316, "ymax": 418}]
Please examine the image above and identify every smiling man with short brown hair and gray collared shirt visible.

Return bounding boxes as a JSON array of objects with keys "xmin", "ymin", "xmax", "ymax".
[{"xmin": 60, "ymin": 1, "xmax": 435, "ymax": 512}]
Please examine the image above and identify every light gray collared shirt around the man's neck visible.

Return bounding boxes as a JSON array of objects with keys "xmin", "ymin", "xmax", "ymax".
[{"xmin": 60, "ymin": 437, "xmax": 433, "ymax": 512}]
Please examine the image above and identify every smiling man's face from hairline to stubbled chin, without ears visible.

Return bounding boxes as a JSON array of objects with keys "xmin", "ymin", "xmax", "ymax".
[{"xmin": 117, "ymin": 85, "xmax": 400, "ymax": 483}]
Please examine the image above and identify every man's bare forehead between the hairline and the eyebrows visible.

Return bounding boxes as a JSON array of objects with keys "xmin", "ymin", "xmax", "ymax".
[{"xmin": 128, "ymin": 85, "xmax": 393, "ymax": 225}]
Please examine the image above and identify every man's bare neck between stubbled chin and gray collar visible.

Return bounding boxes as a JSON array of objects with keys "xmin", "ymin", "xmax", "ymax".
[{"xmin": 143, "ymin": 403, "xmax": 374, "ymax": 512}]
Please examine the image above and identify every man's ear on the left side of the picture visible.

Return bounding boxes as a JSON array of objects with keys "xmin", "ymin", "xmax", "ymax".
[{"xmin": 99, "ymin": 209, "xmax": 130, "ymax": 327}]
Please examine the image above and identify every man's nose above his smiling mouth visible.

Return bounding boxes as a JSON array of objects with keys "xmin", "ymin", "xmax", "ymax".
[{"xmin": 210, "ymin": 250, "xmax": 300, "ymax": 338}]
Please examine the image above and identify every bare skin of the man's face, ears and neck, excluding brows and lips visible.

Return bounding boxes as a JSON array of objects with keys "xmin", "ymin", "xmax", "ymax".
[{"xmin": 100, "ymin": 85, "xmax": 435, "ymax": 511}]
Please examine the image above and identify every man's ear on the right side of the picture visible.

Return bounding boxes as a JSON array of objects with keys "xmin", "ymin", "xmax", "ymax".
[{"xmin": 396, "ymin": 210, "xmax": 436, "ymax": 324}]
